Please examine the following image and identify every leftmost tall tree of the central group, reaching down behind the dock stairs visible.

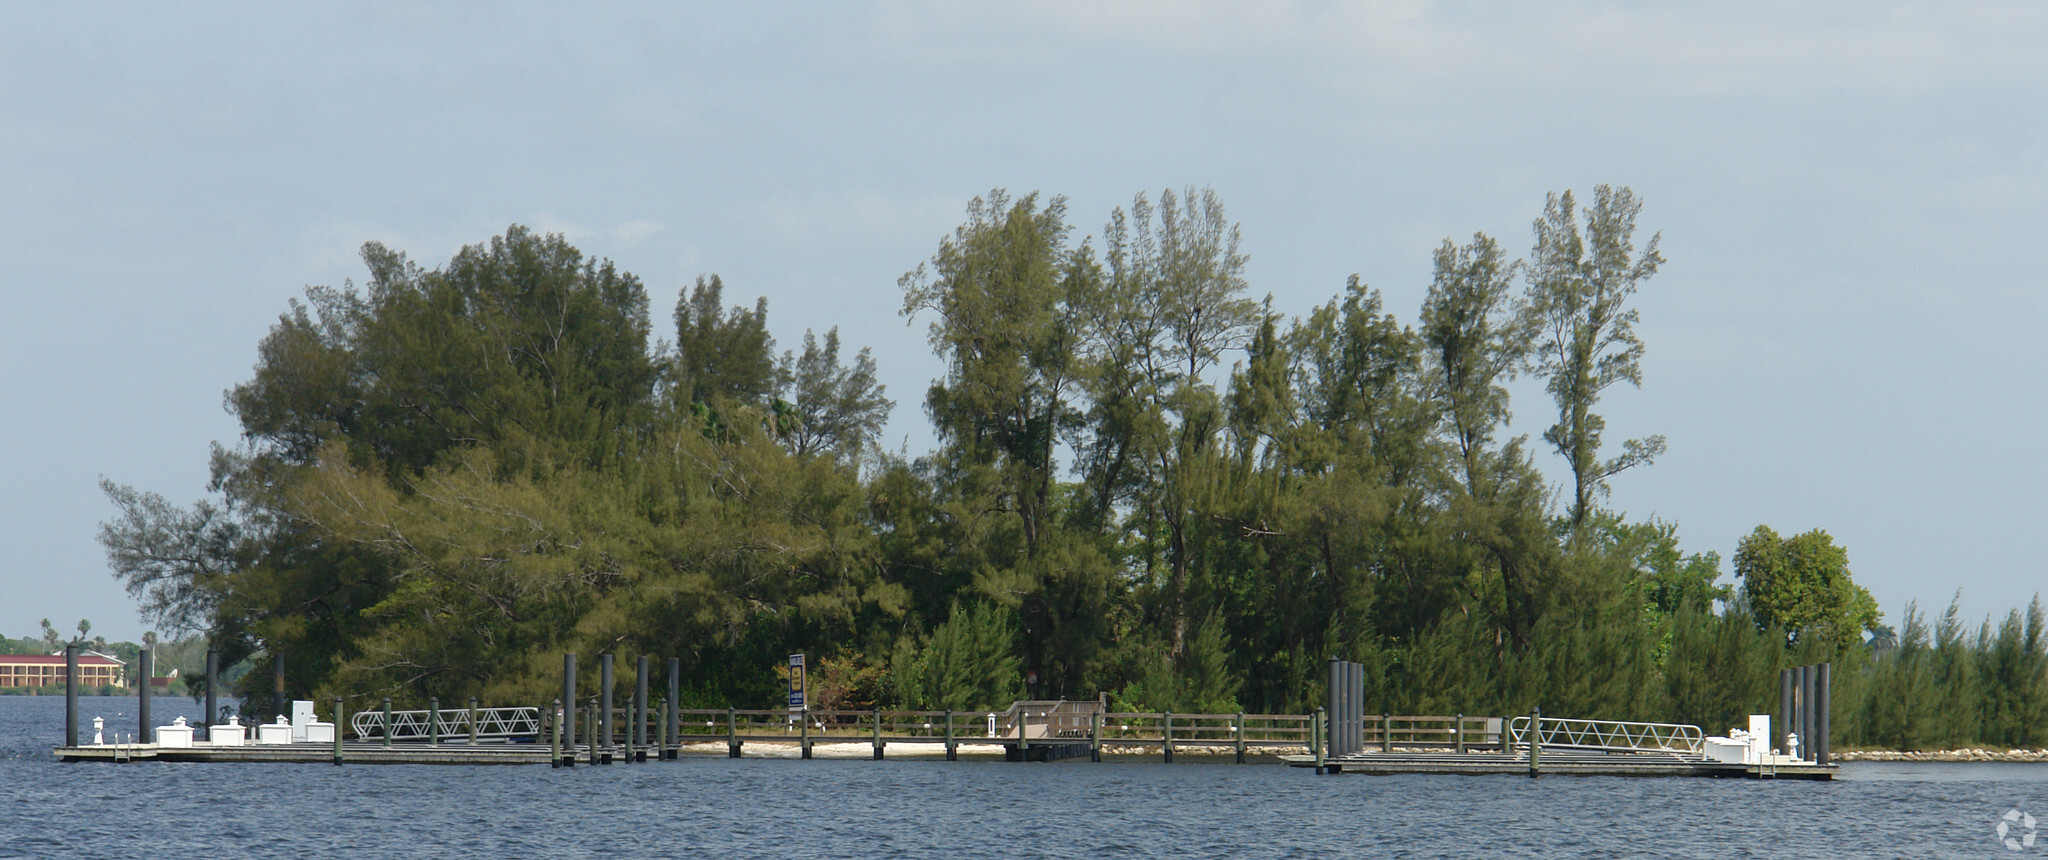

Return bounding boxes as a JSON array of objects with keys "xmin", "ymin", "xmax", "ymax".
[{"xmin": 901, "ymin": 188, "xmax": 1110, "ymax": 692}]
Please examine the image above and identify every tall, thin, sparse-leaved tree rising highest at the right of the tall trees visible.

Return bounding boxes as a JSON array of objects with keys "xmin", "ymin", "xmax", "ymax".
[{"xmin": 1526, "ymin": 184, "xmax": 1665, "ymax": 539}]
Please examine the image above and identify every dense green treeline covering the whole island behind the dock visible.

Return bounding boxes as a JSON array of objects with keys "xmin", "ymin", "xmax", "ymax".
[{"xmin": 102, "ymin": 186, "xmax": 2048, "ymax": 745}]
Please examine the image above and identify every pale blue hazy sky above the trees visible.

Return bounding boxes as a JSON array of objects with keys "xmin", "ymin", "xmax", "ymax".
[{"xmin": 0, "ymin": 0, "xmax": 2048, "ymax": 639}]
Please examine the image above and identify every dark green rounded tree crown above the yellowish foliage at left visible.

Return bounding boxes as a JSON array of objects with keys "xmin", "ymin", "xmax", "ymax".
[{"xmin": 227, "ymin": 225, "xmax": 655, "ymax": 483}]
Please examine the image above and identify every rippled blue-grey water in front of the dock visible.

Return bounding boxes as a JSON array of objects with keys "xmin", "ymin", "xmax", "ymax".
[{"xmin": 0, "ymin": 696, "xmax": 2048, "ymax": 860}]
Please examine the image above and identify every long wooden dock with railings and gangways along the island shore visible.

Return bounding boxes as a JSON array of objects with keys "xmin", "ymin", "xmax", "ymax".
[{"xmin": 53, "ymin": 700, "xmax": 1839, "ymax": 780}]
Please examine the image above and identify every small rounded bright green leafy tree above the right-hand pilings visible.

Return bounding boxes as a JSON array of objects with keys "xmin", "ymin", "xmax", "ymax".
[{"xmin": 1735, "ymin": 526, "xmax": 1880, "ymax": 653}]
